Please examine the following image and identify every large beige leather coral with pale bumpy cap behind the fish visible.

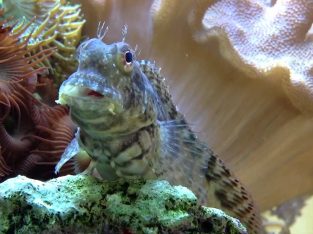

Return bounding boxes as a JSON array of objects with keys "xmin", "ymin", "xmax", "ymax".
[{"xmin": 0, "ymin": 0, "xmax": 313, "ymax": 233}]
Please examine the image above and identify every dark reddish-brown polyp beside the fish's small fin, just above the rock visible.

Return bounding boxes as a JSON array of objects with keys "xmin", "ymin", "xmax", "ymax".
[{"xmin": 0, "ymin": 104, "xmax": 76, "ymax": 181}]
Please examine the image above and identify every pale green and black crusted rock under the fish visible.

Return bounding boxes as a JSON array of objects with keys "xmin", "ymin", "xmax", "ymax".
[{"xmin": 0, "ymin": 175, "xmax": 247, "ymax": 233}]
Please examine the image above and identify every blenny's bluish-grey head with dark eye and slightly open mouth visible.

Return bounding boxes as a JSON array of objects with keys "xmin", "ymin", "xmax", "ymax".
[{"xmin": 57, "ymin": 38, "xmax": 159, "ymax": 136}]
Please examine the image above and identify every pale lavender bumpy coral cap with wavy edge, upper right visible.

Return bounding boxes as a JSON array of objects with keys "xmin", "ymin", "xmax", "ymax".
[{"xmin": 195, "ymin": 0, "xmax": 313, "ymax": 112}]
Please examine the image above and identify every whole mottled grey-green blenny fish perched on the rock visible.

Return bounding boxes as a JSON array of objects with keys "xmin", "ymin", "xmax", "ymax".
[{"xmin": 56, "ymin": 38, "xmax": 262, "ymax": 233}]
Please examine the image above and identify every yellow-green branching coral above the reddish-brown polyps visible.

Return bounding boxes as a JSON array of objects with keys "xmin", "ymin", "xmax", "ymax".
[{"xmin": 2, "ymin": 0, "xmax": 85, "ymax": 86}]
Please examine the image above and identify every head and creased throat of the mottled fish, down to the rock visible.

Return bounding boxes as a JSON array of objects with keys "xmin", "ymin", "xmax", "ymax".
[{"xmin": 58, "ymin": 38, "xmax": 160, "ymax": 179}]
